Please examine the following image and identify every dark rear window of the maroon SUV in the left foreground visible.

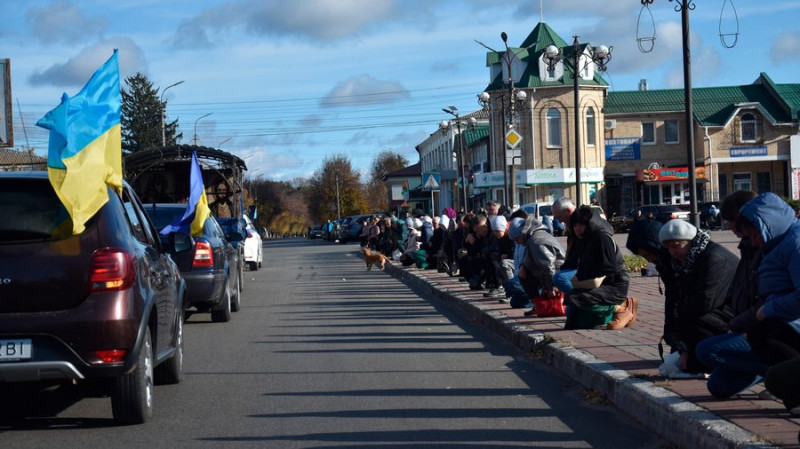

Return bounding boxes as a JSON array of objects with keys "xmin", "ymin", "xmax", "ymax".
[{"xmin": 0, "ymin": 178, "xmax": 72, "ymax": 242}]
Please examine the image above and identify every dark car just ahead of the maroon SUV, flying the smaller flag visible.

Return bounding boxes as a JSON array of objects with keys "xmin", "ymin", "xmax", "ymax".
[{"xmin": 145, "ymin": 203, "xmax": 241, "ymax": 322}]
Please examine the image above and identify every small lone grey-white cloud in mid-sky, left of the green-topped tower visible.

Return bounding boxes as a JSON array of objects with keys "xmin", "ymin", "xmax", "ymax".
[{"xmin": 320, "ymin": 74, "xmax": 411, "ymax": 107}]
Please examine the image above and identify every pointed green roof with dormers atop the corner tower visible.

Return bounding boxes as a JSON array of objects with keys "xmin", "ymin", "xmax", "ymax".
[{"xmin": 485, "ymin": 22, "xmax": 608, "ymax": 91}]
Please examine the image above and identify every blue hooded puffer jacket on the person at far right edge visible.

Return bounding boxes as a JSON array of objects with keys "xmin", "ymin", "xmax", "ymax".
[{"xmin": 739, "ymin": 193, "xmax": 800, "ymax": 333}]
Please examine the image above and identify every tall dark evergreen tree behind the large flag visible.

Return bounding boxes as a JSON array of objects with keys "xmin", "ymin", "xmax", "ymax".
[{"xmin": 121, "ymin": 73, "xmax": 183, "ymax": 155}]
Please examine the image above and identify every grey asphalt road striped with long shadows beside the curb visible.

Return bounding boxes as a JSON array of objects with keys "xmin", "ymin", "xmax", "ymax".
[{"xmin": 0, "ymin": 239, "xmax": 666, "ymax": 449}]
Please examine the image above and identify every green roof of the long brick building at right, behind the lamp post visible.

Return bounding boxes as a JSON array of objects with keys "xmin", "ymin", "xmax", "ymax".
[{"xmin": 604, "ymin": 74, "xmax": 800, "ymax": 126}]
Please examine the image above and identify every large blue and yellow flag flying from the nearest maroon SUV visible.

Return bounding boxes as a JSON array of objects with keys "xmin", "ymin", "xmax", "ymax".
[{"xmin": 36, "ymin": 49, "xmax": 122, "ymax": 234}]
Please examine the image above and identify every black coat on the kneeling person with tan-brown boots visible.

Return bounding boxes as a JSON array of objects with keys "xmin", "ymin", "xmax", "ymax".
[{"xmin": 570, "ymin": 214, "xmax": 630, "ymax": 304}]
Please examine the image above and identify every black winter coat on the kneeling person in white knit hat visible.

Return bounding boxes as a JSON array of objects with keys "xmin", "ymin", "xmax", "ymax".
[{"xmin": 659, "ymin": 236, "xmax": 738, "ymax": 356}]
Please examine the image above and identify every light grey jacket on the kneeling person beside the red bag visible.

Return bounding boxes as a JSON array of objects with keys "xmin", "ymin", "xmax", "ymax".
[{"xmin": 522, "ymin": 215, "xmax": 566, "ymax": 290}]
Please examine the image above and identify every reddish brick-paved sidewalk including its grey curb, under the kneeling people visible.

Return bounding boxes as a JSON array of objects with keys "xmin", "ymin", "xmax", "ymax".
[{"xmin": 386, "ymin": 263, "xmax": 800, "ymax": 449}]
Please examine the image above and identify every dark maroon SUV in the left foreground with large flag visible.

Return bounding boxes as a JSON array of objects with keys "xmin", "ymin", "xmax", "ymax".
[{"xmin": 0, "ymin": 171, "xmax": 192, "ymax": 424}]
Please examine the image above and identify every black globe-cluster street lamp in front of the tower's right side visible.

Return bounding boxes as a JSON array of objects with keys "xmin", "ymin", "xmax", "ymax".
[{"xmin": 544, "ymin": 34, "xmax": 614, "ymax": 206}]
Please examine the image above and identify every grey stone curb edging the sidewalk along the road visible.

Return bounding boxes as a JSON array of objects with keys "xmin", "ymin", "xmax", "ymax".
[{"xmin": 382, "ymin": 258, "xmax": 776, "ymax": 449}]
